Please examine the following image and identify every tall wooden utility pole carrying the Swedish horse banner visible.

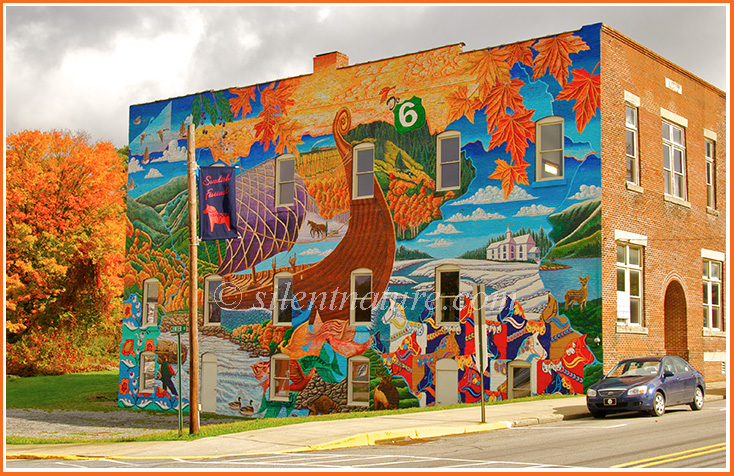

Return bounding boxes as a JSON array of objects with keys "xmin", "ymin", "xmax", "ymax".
[{"xmin": 186, "ymin": 123, "xmax": 199, "ymax": 435}]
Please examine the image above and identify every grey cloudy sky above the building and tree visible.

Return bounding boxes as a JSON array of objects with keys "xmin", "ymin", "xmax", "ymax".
[{"xmin": 3, "ymin": 4, "xmax": 729, "ymax": 147}]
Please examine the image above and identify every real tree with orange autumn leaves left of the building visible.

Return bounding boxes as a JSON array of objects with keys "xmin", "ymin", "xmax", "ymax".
[{"xmin": 5, "ymin": 131, "xmax": 125, "ymax": 375}]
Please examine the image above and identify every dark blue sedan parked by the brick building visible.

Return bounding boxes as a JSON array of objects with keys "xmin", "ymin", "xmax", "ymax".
[{"xmin": 586, "ymin": 355, "xmax": 706, "ymax": 418}]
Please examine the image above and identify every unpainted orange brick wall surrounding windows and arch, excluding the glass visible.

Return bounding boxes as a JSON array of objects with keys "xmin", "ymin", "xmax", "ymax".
[{"xmin": 601, "ymin": 26, "xmax": 728, "ymax": 381}]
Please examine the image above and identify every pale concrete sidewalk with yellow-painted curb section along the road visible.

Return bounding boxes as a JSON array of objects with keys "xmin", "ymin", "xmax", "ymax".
[{"xmin": 6, "ymin": 382, "xmax": 726, "ymax": 459}]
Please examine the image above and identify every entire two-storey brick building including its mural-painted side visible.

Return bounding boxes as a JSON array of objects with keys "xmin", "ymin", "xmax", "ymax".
[{"xmin": 118, "ymin": 24, "xmax": 727, "ymax": 417}]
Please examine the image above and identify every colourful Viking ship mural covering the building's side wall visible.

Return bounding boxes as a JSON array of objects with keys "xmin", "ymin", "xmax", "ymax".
[{"xmin": 118, "ymin": 24, "xmax": 602, "ymax": 417}]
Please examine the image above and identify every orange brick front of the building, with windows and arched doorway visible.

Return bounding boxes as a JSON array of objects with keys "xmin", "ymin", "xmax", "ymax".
[{"xmin": 601, "ymin": 26, "xmax": 727, "ymax": 381}]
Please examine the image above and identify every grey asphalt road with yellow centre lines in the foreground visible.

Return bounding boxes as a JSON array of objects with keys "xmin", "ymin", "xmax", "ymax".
[{"xmin": 6, "ymin": 400, "xmax": 728, "ymax": 471}]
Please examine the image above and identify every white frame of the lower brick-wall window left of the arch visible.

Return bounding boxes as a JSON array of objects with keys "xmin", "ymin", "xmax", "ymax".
[{"xmin": 615, "ymin": 241, "xmax": 645, "ymax": 327}]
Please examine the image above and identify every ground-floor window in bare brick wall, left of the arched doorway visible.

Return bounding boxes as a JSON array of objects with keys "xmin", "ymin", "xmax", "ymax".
[{"xmin": 617, "ymin": 243, "xmax": 642, "ymax": 326}]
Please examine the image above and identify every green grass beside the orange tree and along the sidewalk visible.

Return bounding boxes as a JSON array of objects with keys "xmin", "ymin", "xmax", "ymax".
[{"xmin": 5, "ymin": 371, "xmax": 576, "ymax": 445}]
